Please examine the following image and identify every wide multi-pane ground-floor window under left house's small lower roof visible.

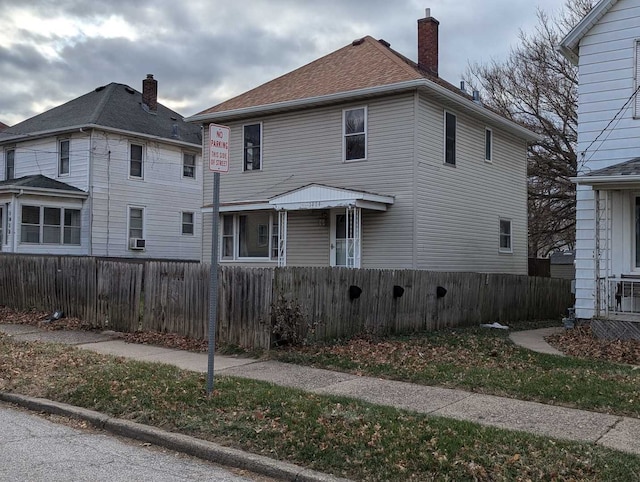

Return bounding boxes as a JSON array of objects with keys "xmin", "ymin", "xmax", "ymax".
[{"xmin": 20, "ymin": 205, "xmax": 80, "ymax": 245}]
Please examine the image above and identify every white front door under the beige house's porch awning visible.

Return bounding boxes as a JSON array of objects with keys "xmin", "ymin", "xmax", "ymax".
[{"xmin": 331, "ymin": 208, "xmax": 360, "ymax": 268}]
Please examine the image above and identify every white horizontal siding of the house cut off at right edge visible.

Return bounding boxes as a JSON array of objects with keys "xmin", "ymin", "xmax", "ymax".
[{"xmin": 576, "ymin": 0, "xmax": 640, "ymax": 319}]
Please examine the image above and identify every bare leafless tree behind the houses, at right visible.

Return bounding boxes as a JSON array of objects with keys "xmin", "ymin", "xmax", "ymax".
[{"xmin": 465, "ymin": 0, "xmax": 595, "ymax": 257}]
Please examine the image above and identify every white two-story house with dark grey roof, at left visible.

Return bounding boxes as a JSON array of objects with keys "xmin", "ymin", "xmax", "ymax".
[{"xmin": 0, "ymin": 75, "xmax": 202, "ymax": 260}]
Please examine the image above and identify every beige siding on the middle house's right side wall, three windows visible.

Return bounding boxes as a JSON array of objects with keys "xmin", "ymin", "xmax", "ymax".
[{"xmin": 416, "ymin": 98, "xmax": 527, "ymax": 274}]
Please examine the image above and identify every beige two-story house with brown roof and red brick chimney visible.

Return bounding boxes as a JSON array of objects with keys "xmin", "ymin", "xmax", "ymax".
[{"xmin": 187, "ymin": 10, "xmax": 535, "ymax": 274}]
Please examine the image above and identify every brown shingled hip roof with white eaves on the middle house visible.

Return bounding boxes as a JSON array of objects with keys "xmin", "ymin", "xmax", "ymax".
[{"xmin": 186, "ymin": 31, "xmax": 538, "ymax": 140}]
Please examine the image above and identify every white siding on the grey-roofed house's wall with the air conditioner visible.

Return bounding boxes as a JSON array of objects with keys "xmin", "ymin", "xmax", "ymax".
[{"xmin": 91, "ymin": 131, "xmax": 202, "ymax": 260}]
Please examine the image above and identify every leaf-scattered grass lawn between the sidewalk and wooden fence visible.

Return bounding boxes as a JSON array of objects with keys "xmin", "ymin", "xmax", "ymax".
[{"xmin": 270, "ymin": 323, "xmax": 640, "ymax": 418}]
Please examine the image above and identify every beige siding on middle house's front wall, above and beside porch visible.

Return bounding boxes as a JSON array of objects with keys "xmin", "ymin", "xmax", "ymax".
[{"xmin": 203, "ymin": 94, "xmax": 414, "ymax": 268}]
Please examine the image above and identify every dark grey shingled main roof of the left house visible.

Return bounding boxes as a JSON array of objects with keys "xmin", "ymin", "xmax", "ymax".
[{"xmin": 0, "ymin": 78, "xmax": 202, "ymax": 145}]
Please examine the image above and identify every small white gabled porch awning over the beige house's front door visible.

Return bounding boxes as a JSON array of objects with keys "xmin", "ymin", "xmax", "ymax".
[{"xmin": 269, "ymin": 184, "xmax": 394, "ymax": 211}]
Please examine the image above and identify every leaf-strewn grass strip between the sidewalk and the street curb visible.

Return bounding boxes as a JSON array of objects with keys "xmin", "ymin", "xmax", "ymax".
[{"xmin": 0, "ymin": 334, "xmax": 640, "ymax": 481}]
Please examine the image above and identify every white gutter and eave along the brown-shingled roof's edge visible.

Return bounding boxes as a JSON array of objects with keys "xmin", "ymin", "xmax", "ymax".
[{"xmin": 184, "ymin": 78, "xmax": 542, "ymax": 141}]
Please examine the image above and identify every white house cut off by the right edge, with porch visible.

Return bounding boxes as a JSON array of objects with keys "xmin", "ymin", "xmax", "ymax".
[{"xmin": 560, "ymin": 0, "xmax": 640, "ymax": 334}]
